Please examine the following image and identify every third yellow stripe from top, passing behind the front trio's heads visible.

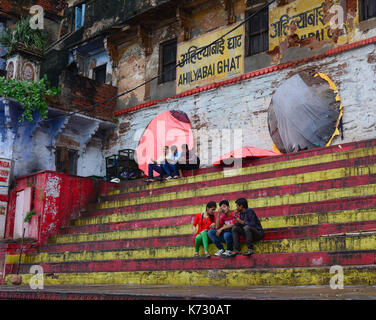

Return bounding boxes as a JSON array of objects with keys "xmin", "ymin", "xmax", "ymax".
[{"xmin": 72, "ymin": 184, "xmax": 376, "ymax": 226}]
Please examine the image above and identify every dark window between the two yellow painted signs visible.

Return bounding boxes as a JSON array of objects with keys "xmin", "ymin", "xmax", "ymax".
[{"xmin": 247, "ymin": 7, "xmax": 269, "ymax": 56}]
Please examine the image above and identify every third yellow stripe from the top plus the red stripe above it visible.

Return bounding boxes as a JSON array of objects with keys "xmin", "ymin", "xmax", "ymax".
[{"xmin": 82, "ymin": 178, "xmax": 376, "ymax": 221}]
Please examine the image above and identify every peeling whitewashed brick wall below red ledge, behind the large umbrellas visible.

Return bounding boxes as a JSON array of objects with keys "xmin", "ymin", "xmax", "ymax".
[{"xmin": 107, "ymin": 44, "xmax": 376, "ymax": 165}]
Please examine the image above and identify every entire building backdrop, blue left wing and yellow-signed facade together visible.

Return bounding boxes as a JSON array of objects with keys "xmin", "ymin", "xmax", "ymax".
[{"xmin": 0, "ymin": 0, "xmax": 376, "ymax": 238}]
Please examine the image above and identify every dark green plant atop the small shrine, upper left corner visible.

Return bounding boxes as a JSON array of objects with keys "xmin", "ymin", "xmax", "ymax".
[{"xmin": 0, "ymin": 18, "xmax": 47, "ymax": 56}]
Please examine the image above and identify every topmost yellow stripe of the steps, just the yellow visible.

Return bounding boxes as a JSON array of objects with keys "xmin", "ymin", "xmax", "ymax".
[{"xmin": 108, "ymin": 147, "xmax": 376, "ymax": 195}]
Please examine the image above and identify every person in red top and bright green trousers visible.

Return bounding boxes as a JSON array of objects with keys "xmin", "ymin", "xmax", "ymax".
[{"xmin": 192, "ymin": 201, "xmax": 217, "ymax": 258}]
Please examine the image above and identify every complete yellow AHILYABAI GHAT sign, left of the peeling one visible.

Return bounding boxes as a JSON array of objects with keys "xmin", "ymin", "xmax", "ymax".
[{"xmin": 176, "ymin": 26, "xmax": 244, "ymax": 93}]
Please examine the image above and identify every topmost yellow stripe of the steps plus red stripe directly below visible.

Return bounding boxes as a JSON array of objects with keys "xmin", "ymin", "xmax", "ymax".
[{"xmin": 102, "ymin": 148, "xmax": 376, "ymax": 201}]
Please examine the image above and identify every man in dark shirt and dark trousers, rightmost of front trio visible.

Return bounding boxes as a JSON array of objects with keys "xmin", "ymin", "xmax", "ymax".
[{"xmin": 231, "ymin": 198, "xmax": 264, "ymax": 256}]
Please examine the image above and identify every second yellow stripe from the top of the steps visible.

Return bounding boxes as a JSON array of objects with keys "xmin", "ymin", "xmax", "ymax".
[{"xmin": 96, "ymin": 164, "xmax": 376, "ymax": 210}]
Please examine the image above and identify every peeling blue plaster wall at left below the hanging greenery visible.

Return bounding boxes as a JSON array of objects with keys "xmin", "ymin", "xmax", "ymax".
[{"xmin": 0, "ymin": 101, "xmax": 106, "ymax": 177}]
